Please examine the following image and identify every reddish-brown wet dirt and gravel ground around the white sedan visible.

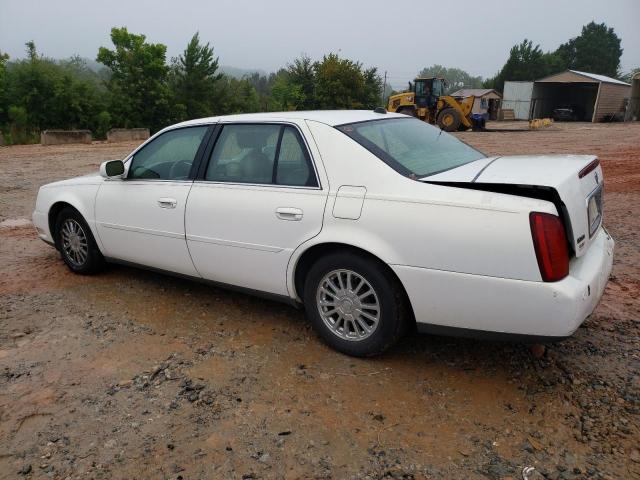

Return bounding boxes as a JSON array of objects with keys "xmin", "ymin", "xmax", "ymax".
[{"xmin": 0, "ymin": 123, "xmax": 640, "ymax": 480}]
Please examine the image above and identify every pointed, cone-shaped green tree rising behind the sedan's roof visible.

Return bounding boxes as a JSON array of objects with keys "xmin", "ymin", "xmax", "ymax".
[{"xmin": 171, "ymin": 33, "xmax": 222, "ymax": 118}]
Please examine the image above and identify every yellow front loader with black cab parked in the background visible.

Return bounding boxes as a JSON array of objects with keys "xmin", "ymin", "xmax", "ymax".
[{"xmin": 387, "ymin": 78, "xmax": 475, "ymax": 132}]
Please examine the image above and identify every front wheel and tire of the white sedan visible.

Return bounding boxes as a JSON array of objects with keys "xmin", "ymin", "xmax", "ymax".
[{"xmin": 55, "ymin": 207, "xmax": 105, "ymax": 275}]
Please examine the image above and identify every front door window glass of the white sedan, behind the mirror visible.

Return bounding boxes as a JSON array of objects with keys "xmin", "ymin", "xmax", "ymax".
[{"xmin": 128, "ymin": 125, "xmax": 209, "ymax": 180}]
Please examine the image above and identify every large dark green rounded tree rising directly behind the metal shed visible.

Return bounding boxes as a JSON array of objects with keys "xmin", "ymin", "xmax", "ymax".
[{"xmin": 555, "ymin": 22, "xmax": 622, "ymax": 77}]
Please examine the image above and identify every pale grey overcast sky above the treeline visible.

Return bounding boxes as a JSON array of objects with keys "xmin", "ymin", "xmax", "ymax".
[{"xmin": 0, "ymin": 0, "xmax": 640, "ymax": 85}]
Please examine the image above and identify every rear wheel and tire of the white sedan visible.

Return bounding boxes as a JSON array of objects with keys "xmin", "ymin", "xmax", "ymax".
[{"xmin": 304, "ymin": 252, "xmax": 407, "ymax": 357}]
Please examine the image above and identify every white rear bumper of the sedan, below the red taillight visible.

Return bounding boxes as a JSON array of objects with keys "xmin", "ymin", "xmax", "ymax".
[{"xmin": 392, "ymin": 228, "xmax": 614, "ymax": 340}]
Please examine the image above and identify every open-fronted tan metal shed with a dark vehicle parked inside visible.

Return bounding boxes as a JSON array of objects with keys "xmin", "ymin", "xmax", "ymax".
[{"xmin": 530, "ymin": 70, "xmax": 631, "ymax": 122}]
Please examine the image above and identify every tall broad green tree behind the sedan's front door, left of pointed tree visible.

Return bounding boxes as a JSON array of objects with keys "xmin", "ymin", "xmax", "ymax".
[{"xmin": 97, "ymin": 27, "xmax": 175, "ymax": 132}]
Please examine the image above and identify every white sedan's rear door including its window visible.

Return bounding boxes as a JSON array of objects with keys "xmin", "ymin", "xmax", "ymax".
[{"xmin": 185, "ymin": 123, "xmax": 327, "ymax": 295}]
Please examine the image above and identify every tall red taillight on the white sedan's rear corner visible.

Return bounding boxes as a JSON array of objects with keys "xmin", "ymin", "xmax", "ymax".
[{"xmin": 529, "ymin": 212, "xmax": 569, "ymax": 282}]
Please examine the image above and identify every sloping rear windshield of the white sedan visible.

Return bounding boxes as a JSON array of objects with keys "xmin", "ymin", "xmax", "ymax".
[{"xmin": 336, "ymin": 118, "xmax": 486, "ymax": 178}]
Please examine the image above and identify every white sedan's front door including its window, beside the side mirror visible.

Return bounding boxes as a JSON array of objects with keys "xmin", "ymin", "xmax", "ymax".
[{"xmin": 95, "ymin": 125, "xmax": 210, "ymax": 276}]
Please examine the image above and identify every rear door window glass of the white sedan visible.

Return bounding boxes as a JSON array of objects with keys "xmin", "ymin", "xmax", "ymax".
[{"xmin": 205, "ymin": 124, "xmax": 318, "ymax": 187}]
